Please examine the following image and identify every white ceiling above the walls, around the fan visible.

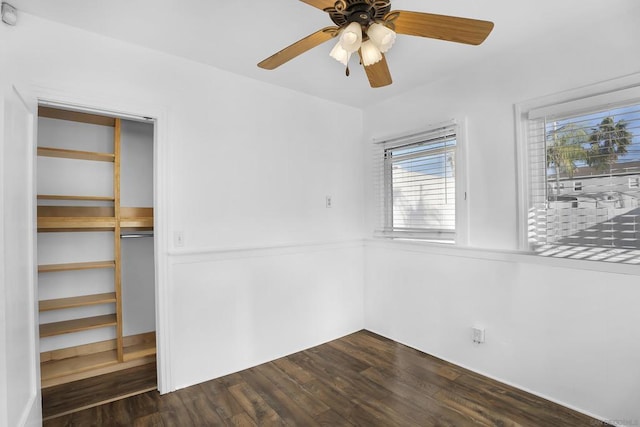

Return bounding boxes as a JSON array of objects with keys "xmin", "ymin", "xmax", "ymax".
[{"xmin": 9, "ymin": 0, "xmax": 640, "ymax": 108}]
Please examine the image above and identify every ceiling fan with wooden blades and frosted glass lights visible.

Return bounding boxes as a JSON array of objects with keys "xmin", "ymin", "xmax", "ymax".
[{"xmin": 258, "ymin": 0, "xmax": 493, "ymax": 87}]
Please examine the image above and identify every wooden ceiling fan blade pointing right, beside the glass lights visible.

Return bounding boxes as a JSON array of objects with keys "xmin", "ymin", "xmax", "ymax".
[{"xmin": 384, "ymin": 10, "xmax": 493, "ymax": 45}]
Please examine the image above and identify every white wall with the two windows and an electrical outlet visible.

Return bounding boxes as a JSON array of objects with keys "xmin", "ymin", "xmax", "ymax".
[{"xmin": 363, "ymin": 5, "xmax": 640, "ymax": 423}]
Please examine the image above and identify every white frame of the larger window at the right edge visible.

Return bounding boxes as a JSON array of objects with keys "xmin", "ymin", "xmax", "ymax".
[{"xmin": 514, "ymin": 73, "xmax": 640, "ymax": 264}]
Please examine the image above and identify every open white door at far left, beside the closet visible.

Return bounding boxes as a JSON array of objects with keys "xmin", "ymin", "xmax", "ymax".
[{"xmin": 0, "ymin": 85, "xmax": 42, "ymax": 426}]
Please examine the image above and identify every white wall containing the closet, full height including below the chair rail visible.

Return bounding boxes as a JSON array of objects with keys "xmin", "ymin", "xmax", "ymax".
[{"xmin": 0, "ymin": 14, "xmax": 363, "ymax": 389}]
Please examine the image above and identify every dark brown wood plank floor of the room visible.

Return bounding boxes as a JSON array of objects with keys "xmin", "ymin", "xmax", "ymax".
[{"xmin": 45, "ymin": 331, "xmax": 606, "ymax": 427}]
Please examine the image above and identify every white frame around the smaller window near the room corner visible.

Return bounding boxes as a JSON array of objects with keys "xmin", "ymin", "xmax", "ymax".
[{"xmin": 373, "ymin": 118, "xmax": 469, "ymax": 246}]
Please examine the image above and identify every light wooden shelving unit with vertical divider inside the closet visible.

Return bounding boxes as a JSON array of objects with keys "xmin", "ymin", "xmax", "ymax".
[{"xmin": 37, "ymin": 107, "xmax": 156, "ymax": 387}]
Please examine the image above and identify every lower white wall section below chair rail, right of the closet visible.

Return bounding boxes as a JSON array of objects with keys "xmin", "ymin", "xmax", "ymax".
[{"xmin": 171, "ymin": 241, "xmax": 364, "ymax": 386}]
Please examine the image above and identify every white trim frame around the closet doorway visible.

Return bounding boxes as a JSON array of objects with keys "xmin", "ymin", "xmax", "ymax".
[{"xmin": 30, "ymin": 86, "xmax": 175, "ymax": 394}]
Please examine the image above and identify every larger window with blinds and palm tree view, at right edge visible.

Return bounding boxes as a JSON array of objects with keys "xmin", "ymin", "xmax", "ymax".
[{"xmin": 520, "ymin": 79, "xmax": 640, "ymax": 264}]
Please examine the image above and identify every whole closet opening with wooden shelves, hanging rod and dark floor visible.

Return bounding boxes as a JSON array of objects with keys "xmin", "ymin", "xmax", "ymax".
[{"xmin": 35, "ymin": 103, "xmax": 158, "ymax": 419}]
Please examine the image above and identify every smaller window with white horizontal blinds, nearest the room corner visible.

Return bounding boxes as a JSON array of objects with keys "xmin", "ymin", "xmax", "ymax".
[{"xmin": 375, "ymin": 122, "xmax": 460, "ymax": 243}]
